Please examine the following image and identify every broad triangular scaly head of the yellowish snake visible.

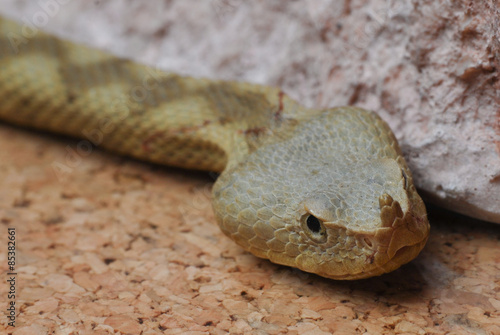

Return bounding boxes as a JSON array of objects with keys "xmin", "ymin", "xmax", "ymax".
[{"xmin": 213, "ymin": 108, "xmax": 429, "ymax": 280}]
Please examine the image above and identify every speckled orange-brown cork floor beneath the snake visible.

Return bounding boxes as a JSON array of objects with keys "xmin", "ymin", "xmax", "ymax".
[{"xmin": 0, "ymin": 124, "xmax": 500, "ymax": 335}]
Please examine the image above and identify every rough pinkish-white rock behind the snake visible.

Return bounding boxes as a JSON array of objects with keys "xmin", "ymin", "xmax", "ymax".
[{"xmin": 2, "ymin": 0, "xmax": 500, "ymax": 223}]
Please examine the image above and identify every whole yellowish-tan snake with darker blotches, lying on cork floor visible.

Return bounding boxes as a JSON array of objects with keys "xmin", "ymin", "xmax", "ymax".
[{"xmin": 0, "ymin": 18, "xmax": 430, "ymax": 280}]
